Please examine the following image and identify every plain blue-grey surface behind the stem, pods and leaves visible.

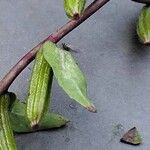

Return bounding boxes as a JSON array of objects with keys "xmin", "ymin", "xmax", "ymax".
[{"xmin": 0, "ymin": 0, "xmax": 150, "ymax": 150}]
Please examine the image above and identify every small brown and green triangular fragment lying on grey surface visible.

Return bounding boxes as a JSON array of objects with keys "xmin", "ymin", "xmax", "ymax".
[{"xmin": 120, "ymin": 127, "xmax": 142, "ymax": 145}]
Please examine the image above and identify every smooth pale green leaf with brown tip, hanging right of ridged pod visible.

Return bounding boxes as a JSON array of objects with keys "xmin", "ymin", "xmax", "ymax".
[{"xmin": 43, "ymin": 42, "xmax": 96, "ymax": 112}]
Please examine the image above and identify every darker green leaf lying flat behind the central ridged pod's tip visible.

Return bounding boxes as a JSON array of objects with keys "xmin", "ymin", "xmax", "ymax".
[{"xmin": 10, "ymin": 99, "xmax": 68, "ymax": 133}]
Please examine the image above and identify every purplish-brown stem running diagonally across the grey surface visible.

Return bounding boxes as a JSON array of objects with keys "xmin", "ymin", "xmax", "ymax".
[{"xmin": 0, "ymin": 0, "xmax": 109, "ymax": 94}]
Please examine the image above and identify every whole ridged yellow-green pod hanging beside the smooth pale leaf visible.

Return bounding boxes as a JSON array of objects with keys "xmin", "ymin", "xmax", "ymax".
[{"xmin": 26, "ymin": 48, "xmax": 53, "ymax": 128}]
